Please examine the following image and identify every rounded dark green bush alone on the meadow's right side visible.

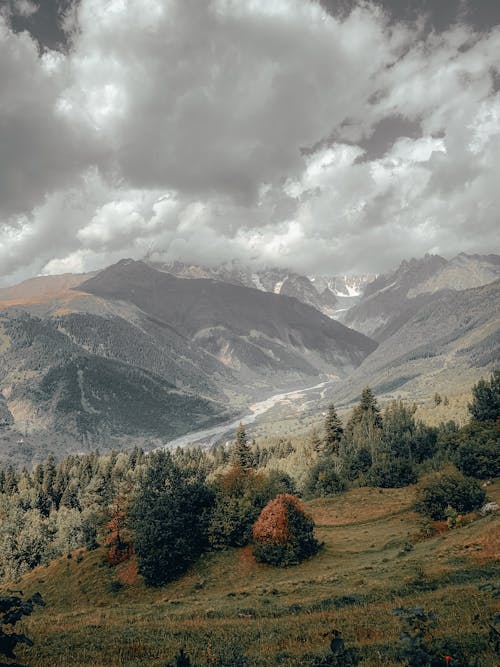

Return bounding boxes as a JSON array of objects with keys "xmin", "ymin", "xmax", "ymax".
[{"xmin": 415, "ymin": 473, "xmax": 486, "ymax": 520}]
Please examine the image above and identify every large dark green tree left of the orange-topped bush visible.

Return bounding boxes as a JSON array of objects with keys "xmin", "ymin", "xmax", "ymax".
[{"xmin": 131, "ymin": 451, "xmax": 212, "ymax": 586}]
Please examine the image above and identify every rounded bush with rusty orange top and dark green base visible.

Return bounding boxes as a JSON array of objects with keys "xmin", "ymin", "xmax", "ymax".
[{"xmin": 253, "ymin": 493, "xmax": 319, "ymax": 567}]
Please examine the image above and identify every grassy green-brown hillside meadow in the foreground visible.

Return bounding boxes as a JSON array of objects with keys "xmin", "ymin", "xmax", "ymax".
[{"xmin": 7, "ymin": 480, "xmax": 500, "ymax": 667}]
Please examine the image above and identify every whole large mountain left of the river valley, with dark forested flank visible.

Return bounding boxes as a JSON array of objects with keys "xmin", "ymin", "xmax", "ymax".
[{"xmin": 0, "ymin": 260, "xmax": 376, "ymax": 458}]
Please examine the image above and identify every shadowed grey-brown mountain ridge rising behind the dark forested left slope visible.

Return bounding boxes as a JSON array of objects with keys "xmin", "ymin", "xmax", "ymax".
[{"xmin": 79, "ymin": 260, "xmax": 375, "ymax": 370}]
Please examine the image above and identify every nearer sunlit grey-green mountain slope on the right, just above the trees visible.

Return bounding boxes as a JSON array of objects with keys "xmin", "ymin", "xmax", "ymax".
[{"xmin": 336, "ymin": 280, "xmax": 500, "ymax": 402}]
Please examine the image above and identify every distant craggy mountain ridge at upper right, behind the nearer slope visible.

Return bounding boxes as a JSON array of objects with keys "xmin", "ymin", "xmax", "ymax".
[{"xmin": 342, "ymin": 253, "xmax": 500, "ymax": 341}]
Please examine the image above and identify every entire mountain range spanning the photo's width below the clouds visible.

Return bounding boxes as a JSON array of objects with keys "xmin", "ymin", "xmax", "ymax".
[{"xmin": 0, "ymin": 254, "xmax": 500, "ymax": 461}]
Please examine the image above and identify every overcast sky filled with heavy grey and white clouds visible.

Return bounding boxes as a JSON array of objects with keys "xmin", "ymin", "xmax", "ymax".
[{"xmin": 0, "ymin": 0, "xmax": 500, "ymax": 285}]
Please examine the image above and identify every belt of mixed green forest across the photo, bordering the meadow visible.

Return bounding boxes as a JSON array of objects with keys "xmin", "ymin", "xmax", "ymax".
[{"xmin": 0, "ymin": 371, "xmax": 500, "ymax": 585}]
